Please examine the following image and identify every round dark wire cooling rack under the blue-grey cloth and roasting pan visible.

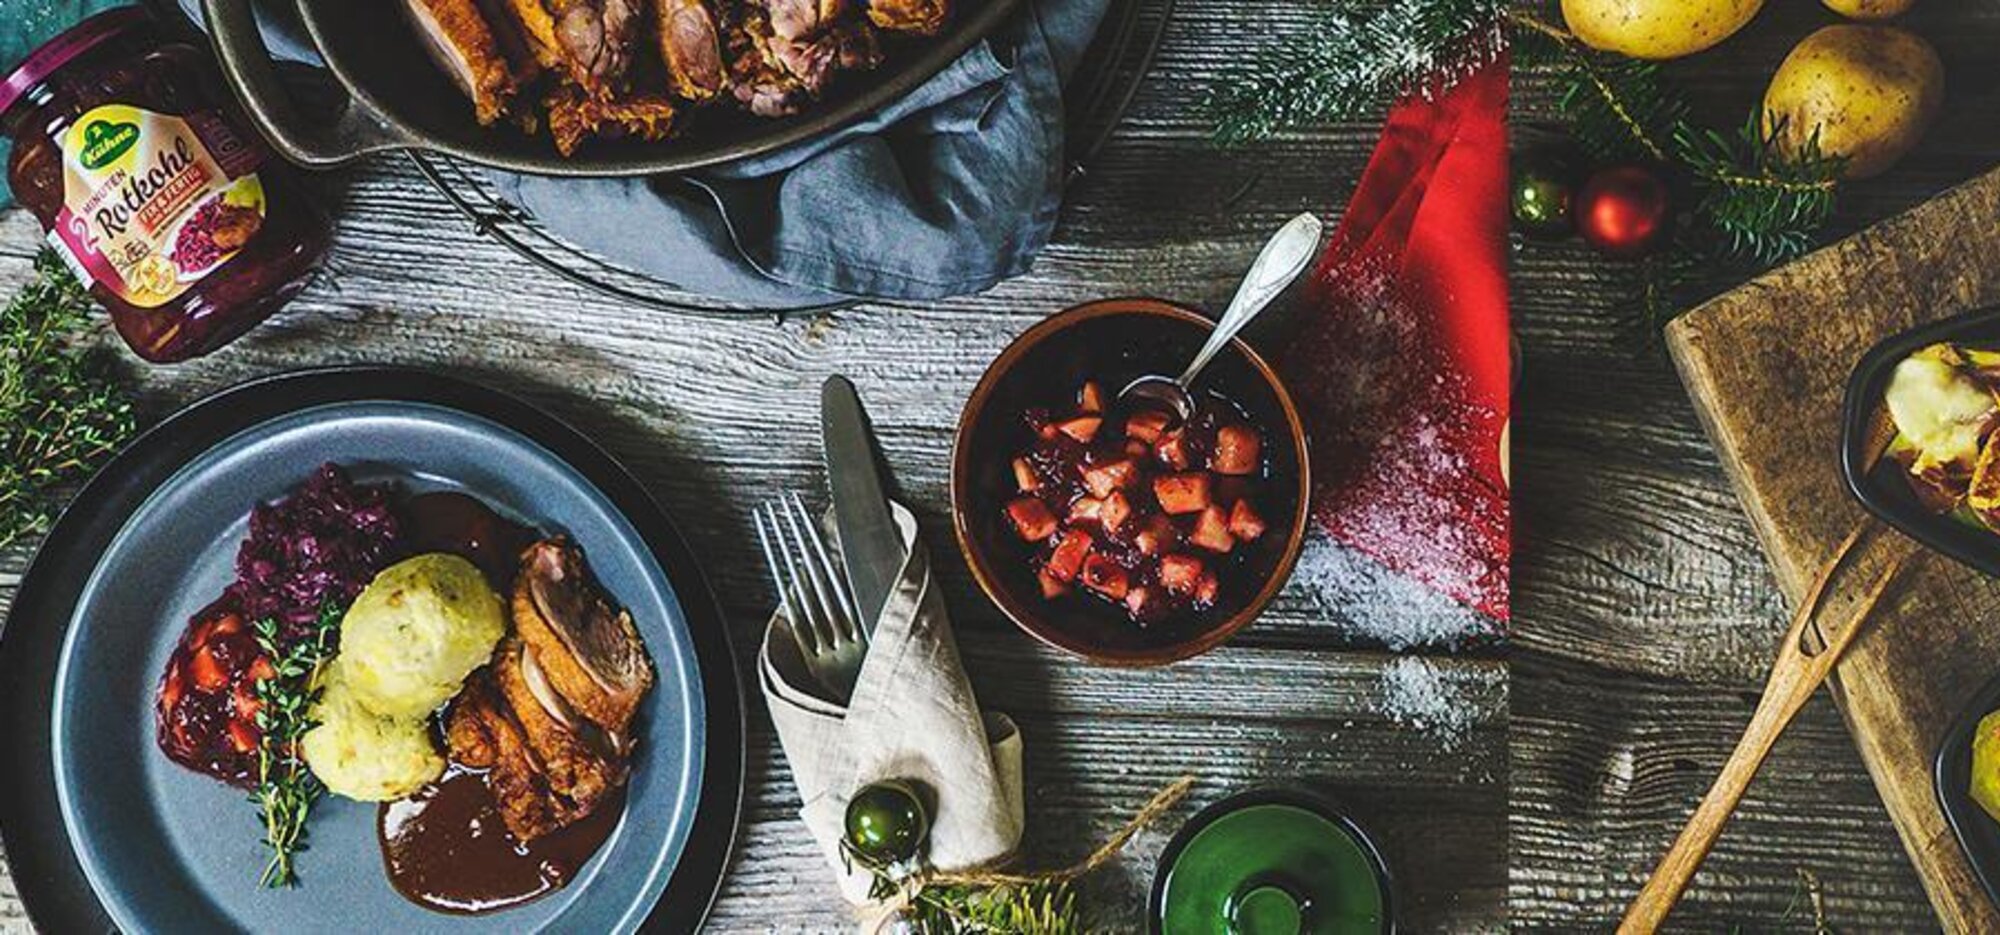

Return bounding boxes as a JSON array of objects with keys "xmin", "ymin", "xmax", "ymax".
[{"xmin": 408, "ymin": 0, "xmax": 1176, "ymax": 318}]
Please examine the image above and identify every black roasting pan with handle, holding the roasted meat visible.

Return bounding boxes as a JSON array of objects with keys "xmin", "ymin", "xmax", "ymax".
[{"xmin": 202, "ymin": 0, "xmax": 1020, "ymax": 176}]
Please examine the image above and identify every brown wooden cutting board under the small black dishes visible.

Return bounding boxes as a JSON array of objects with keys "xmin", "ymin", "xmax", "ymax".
[{"xmin": 1666, "ymin": 164, "xmax": 2000, "ymax": 933}]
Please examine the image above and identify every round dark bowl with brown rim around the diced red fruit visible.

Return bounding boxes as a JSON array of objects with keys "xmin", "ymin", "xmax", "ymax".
[{"xmin": 952, "ymin": 298, "xmax": 1312, "ymax": 665}]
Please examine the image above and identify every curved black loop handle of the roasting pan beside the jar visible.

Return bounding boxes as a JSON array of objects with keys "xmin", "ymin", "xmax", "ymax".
[{"xmin": 202, "ymin": 0, "xmax": 416, "ymax": 168}]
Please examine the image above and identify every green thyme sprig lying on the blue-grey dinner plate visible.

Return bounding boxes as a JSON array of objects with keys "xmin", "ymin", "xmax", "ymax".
[{"xmin": 250, "ymin": 601, "xmax": 344, "ymax": 887}]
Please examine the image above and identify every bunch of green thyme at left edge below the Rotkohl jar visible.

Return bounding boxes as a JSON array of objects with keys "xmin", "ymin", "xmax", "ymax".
[{"xmin": 0, "ymin": 250, "xmax": 138, "ymax": 549}]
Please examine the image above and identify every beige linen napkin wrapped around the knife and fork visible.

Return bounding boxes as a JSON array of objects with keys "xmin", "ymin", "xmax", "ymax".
[{"xmin": 758, "ymin": 503, "xmax": 1022, "ymax": 903}]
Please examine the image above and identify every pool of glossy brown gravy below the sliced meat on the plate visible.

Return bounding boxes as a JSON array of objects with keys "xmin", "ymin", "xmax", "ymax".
[{"xmin": 376, "ymin": 763, "xmax": 624, "ymax": 915}]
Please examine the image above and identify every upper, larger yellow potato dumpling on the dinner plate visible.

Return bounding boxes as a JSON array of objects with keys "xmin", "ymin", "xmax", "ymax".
[{"xmin": 332, "ymin": 553, "xmax": 506, "ymax": 717}]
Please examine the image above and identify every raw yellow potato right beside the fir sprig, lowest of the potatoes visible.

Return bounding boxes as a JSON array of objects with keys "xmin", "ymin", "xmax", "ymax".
[{"xmin": 1764, "ymin": 24, "xmax": 1944, "ymax": 178}]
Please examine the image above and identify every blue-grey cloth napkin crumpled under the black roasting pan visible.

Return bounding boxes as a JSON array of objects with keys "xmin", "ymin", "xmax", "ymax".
[{"xmin": 152, "ymin": 0, "xmax": 1108, "ymax": 308}]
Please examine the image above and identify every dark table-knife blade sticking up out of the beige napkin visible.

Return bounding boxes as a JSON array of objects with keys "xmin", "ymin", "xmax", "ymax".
[{"xmin": 820, "ymin": 376, "xmax": 904, "ymax": 635}]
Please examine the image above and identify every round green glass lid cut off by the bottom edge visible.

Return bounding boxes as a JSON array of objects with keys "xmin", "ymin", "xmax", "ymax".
[{"xmin": 1148, "ymin": 789, "xmax": 1394, "ymax": 935}]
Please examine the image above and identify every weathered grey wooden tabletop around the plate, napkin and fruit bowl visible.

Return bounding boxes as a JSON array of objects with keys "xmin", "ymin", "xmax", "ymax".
[{"xmin": 0, "ymin": 0, "xmax": 1504, "ymax": 931}]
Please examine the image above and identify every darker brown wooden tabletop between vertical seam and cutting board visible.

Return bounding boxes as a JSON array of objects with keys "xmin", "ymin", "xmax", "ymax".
[{"xmin": 1510, "ymin": 2, "xmax": 2000, "ymax": 931}]
